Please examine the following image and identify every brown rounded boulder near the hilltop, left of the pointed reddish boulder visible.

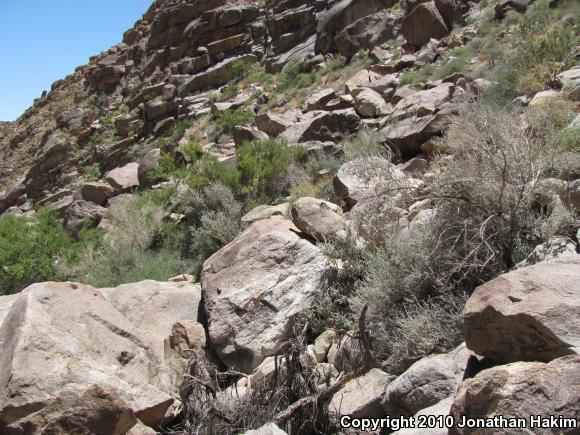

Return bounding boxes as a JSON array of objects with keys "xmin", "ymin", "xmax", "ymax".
[{"xmin": 334, "ymin": 12, "xmax": 398, "ymax": 59}]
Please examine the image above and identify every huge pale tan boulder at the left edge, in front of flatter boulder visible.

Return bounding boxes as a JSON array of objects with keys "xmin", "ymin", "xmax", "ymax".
[{"xmin": 0, "ymin": 283, "xmax": 179, "ymax": 427}]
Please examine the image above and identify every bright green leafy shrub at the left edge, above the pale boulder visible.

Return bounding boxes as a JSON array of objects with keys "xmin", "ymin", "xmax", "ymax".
[{"xmin": 0, "ymin": 209, "xmax": 86, "ymax": 295}]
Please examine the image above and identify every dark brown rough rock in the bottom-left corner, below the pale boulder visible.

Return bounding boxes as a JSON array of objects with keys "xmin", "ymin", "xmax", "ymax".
[{"xmin": 0, "ymin": 385, "xmax": 137, "ymax": 435}]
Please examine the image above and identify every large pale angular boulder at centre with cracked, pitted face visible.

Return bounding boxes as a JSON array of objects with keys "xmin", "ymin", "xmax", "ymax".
[{"xmin": 201, "ymin": 218, "xmax": 328, "ymax": 373}]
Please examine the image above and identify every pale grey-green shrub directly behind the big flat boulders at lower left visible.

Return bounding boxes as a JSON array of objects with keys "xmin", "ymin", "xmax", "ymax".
[{"xmin": 59, "ymin": 192, "xmax": 186, "ymax": 287}]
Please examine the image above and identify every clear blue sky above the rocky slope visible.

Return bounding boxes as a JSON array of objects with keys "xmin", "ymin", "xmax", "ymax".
[{"xmin": 0, "ymin": 0, "xmax": 153, "ymax": 121}]
